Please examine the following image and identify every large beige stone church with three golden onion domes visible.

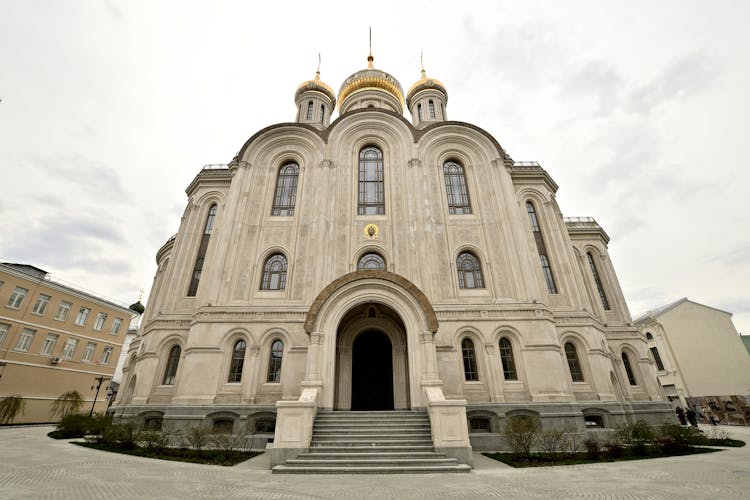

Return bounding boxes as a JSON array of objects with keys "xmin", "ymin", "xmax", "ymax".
[{"xmin": 115, "ymin": 55, "xmax": 672, "ymax": 472}]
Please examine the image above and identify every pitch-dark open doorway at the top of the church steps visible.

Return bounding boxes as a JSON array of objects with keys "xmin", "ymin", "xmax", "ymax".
[{"xmin": 352, "ymin": 330, "xmax": 393, "ymax": 411}]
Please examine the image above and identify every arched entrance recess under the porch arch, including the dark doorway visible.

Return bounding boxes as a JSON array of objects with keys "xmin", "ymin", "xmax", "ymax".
[{"xmin": 334, "ymin": 303, "xmax": 409, "ymax": 411}]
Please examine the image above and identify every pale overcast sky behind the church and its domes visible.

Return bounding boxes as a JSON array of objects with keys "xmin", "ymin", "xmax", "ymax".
[{"xmin": 0, "ymin": 0, "xmax": 750, "ymax": 333}]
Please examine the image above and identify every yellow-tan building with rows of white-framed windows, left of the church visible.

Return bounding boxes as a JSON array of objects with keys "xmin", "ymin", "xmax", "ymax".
[{"xmin": 0, "ymin": 263, "xmax": 136, "ymax": 423}]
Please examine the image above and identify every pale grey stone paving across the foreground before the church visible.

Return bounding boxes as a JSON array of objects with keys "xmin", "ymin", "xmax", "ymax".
[{"xmin": 0, "ymin": 427, "xmax": 750, "ymax": 500}]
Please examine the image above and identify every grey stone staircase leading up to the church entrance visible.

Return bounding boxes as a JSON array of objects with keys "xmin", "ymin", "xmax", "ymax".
[{"xmin": 272, "ymin": 410, "xmax": 471, "ymax": 474}]
